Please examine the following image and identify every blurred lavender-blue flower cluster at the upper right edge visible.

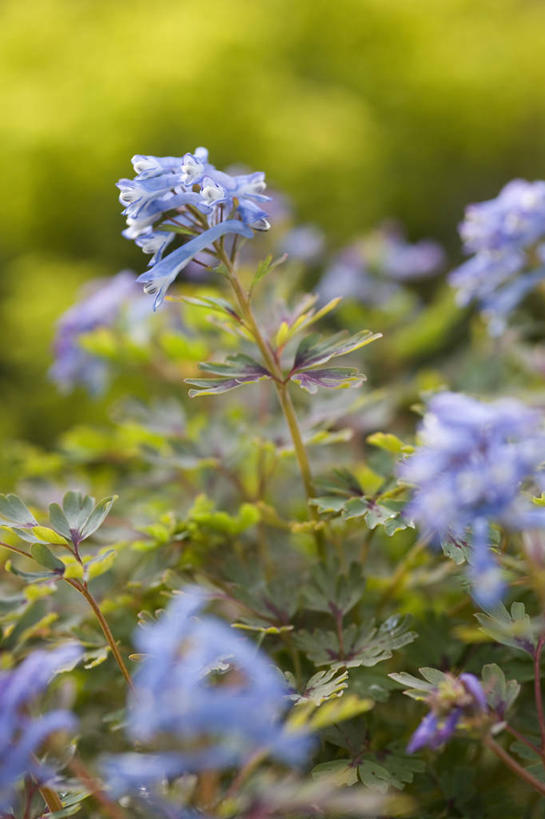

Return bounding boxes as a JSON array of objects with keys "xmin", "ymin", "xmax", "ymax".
[{"xmin": 449, "ymin": 179, "xmax": 545, "ymax": 335}]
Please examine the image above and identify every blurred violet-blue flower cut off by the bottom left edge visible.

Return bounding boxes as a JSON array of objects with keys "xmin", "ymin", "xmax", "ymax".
[{"xmin": 0, "ymin": 643, "xmax": 82, "ymax": 811}]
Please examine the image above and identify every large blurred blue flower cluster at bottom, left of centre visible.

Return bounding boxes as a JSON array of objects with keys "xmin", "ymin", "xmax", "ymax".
[{"xmin": 105, "ymin": 587, "xmax": 309, "ymax": 793}]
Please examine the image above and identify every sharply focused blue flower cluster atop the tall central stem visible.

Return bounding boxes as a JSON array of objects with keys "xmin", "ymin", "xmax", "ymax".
[{"xmin": 117, "ymin": 148, "xmax": 269, "ymax": 309}]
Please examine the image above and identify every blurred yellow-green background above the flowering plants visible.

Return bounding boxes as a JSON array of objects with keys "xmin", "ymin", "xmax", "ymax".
[{"xmin": 0, "ymin": 0, "xmax": 545, "ymax": 443}]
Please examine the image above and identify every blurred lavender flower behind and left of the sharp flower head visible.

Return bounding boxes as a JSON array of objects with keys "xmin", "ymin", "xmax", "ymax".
[{"xmin": 49, "ymin": 270, "xmax": 143, "ymax": 394}]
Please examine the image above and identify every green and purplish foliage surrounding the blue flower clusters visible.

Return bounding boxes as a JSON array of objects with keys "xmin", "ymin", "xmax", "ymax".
[{"xmin": 0, "ymin": 207, "xmax": 545, "ymax": 819}]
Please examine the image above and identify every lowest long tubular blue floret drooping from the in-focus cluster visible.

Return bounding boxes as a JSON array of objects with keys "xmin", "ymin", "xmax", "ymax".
[{"xmin": 136, "ymin": 219, "xmax": 253, "ymax": 310}]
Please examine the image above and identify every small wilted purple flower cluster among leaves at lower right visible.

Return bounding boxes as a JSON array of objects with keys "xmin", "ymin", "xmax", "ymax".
[{"xmin": 407, "ymin": 674, "xmax": 488, "ymax": 754}]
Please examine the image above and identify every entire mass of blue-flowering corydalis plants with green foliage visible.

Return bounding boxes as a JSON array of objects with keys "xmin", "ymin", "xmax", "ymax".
[{"xmin": 0, "ymin": 148, "xmax": 545, "ymax": 819}]
